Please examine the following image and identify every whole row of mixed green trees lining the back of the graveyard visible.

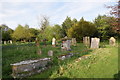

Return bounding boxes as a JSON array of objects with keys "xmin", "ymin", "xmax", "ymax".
[{"xmin": 0, "ymin": 15, "xmax": 120, "ymax": 41}]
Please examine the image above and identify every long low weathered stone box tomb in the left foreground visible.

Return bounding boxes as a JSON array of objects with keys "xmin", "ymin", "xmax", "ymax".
[{"xmin": 11, "ymin": 58, "xmax": 52, "ymax": 78}]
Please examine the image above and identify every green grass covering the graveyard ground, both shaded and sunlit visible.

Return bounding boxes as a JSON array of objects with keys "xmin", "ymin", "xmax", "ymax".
[{"xmin": 2, "ymin": 42, "xmax": 118, "ymax": 80}]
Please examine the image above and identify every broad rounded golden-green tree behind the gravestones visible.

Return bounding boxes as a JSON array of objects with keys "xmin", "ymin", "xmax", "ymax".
[{"xmin": 67, "ymin": 18, "xmax": 96, "ymax": 41}]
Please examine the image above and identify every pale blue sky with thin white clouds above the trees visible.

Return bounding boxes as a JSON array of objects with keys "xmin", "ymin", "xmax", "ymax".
[{"xmin": 0, "ymin": 0, "xmax": 118, "ymax": 30}]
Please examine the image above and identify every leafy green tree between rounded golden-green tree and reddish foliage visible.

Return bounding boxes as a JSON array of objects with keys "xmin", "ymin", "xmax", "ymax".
[{"xmin": 94, "ymin": 15, "xmax": 115, "ymax": 39}]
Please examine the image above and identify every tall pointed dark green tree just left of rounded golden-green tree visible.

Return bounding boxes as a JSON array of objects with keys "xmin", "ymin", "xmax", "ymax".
[{"xmin": 62, "ymin": 16, "xmax": 73, "ymax": 36}]
